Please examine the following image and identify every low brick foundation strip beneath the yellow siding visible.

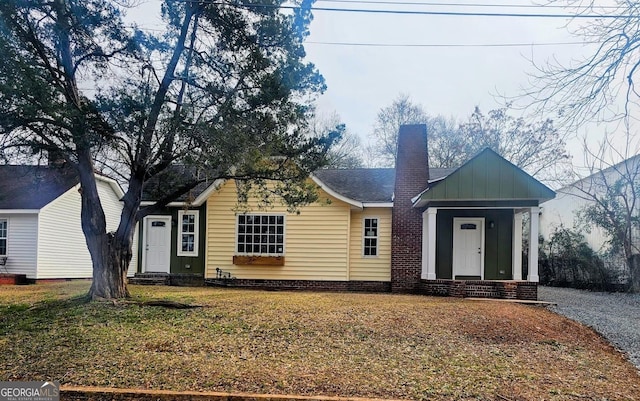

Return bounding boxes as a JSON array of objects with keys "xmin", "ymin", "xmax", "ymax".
[{"xmin": 205, "ymin": 279, "xmax": 391, "ymax": 292}]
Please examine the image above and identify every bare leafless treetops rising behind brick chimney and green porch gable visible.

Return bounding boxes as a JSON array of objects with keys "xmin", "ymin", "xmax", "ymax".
[{"xmin": 368, "ymin": 95, "xmax": 569, "ymax": 182}]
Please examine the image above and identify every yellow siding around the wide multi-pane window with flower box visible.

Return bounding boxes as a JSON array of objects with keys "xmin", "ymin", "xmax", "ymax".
[{"xmin": 205, "ymin": 181, "xmax": 350, "ymax": 281}]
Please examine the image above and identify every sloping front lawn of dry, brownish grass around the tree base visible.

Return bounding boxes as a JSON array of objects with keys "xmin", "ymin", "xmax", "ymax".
[{"xmin": 0, "ymin": 282, "xmax": 640, "ymax": 400}]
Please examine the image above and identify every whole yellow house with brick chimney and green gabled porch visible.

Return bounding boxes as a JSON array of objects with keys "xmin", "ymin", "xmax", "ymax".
[{"xmin": 138, "ymin": 125, "xmax": 555, "ymax": 299}]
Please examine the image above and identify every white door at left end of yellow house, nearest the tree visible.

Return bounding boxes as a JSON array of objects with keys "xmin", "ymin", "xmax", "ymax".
[{"xmin": 143, "ymin": 216, "xmax": 171, "ymax": 273}]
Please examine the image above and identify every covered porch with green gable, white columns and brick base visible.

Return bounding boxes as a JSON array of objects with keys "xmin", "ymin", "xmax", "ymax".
[{"xmin": 413, "ymin": 149, "xmax": 555, "ymax": 300}]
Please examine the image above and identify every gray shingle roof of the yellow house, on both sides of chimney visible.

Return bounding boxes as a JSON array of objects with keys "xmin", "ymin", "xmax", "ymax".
[{"xmin": 313, "ymin": 168, "xmax": 456, "ymax": 203}]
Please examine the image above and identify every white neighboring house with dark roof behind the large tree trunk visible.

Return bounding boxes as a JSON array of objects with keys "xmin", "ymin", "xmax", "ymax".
[{"xmin": 0, "ymin": 165, "xmax": 137, "ymax": 280}]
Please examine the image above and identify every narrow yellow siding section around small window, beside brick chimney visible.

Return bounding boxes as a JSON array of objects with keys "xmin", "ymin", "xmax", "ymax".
[{"xmin": 349, "ymin": 208, "xmax": 391, "ymax": 281}]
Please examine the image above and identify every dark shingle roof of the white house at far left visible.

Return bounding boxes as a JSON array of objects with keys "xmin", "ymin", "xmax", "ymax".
[{"xmin": 0, "ymin": 165, "xmax": 79, "ymax": 209}]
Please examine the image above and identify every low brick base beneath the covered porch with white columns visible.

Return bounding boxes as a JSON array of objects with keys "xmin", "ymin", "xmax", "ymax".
[{"xmin": 419, "ymin": 280, "xmax": 538, "ymax": 301}]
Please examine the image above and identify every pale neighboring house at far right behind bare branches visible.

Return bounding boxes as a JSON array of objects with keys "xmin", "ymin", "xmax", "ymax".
[{"xmin": 540, "ymin": 155, "xmax": 640, "ymax": 251}]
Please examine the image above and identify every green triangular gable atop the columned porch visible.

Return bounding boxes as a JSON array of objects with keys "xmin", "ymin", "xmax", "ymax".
[{"xmin": 414, "ymin": 148, "xmax": 555, "ymax": 207}]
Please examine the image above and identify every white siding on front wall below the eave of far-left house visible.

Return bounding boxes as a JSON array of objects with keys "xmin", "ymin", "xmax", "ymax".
[{"xmin": 0, "ymin": 212, "xmax": 38, "ymax": 278}]
